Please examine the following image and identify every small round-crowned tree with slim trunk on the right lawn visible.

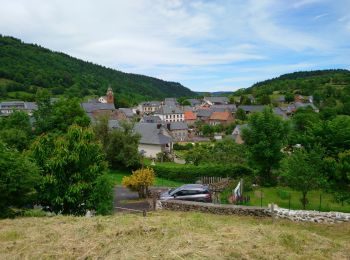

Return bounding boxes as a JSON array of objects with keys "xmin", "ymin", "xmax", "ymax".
[{"xmin": 281, "ymin": 147, "xmax": 326, "ymax": 209}]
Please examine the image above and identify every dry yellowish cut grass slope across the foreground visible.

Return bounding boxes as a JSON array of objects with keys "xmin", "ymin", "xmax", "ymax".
[{"xmin": 0, "ymin": 212, "xmax": 350, "ymax": 259}]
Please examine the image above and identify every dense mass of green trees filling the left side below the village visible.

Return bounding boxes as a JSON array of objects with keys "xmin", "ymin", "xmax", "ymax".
[{"xmin": 0, "ymin": 91, "xmax": 140, "ymax": 218}]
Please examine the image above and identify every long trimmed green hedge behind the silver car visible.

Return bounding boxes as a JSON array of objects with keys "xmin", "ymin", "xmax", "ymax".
[{"xmin": 152, "ymin": 164, "xmax": 253, "ymax": 183}]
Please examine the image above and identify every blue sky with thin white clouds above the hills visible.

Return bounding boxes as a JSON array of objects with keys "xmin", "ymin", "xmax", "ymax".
[{"xmin": 0, "ymin": 0, "xmax": 350, "ymax": 92}]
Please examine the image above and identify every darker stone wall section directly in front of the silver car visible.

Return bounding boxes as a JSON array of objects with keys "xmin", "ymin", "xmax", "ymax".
[{"xmin": 160, "ymin": 200, "xmax": 272, "ymax": 217}]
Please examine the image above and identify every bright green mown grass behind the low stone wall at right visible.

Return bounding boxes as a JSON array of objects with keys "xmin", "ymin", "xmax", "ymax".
[{"xmin": 245, "ymin": 187, "xmax": 350, "ymax": 212}]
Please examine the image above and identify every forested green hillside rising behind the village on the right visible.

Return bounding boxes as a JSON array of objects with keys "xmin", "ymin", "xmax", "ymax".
[{"xmin": 233, "ymin": 69, "xmax": 350, "ymax": 115}]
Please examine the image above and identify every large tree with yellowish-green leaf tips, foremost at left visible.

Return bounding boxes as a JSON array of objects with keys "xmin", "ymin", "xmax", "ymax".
[{"xmin": 31, "ymin": 125, "xmax": 109, "ymax": 215}]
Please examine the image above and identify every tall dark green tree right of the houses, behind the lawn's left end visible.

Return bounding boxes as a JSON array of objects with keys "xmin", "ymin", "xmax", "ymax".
[{"xmin": 243, "ymin": 107, "xmax": 289, "ymax": 185}]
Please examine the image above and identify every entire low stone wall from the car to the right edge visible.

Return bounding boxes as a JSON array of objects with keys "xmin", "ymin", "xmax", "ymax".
[{"xmin": 157, "ymin": 200, "xmax": 350, "ymax": 224}]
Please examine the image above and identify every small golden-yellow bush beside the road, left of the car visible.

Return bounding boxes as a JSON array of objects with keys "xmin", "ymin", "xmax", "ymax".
[{"xmin": 122, "ymin": 168, "xmax": 155, "ymax": 198}]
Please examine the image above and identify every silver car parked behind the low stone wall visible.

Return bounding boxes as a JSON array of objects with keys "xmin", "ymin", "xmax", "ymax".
[{"xmin": 160, "ymin": 184, "xmax": 212, "ymax": 202}]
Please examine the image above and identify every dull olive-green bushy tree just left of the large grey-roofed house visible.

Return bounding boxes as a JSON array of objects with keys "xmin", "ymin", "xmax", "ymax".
[{"xmin": 94, "ymin": 117, "xmax": 141, "ymax": 169}]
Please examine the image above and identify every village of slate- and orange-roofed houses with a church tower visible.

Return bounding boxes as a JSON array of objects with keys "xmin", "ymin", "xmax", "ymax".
[{"xmin": 0, "ymin": 88, "xmax": 319, "ymax": 159}]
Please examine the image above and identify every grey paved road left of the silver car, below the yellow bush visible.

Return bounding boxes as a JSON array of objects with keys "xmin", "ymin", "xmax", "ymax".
[{"xmin": 114, "ymin": 186, "xmax": 168, "ymax": 213}]
